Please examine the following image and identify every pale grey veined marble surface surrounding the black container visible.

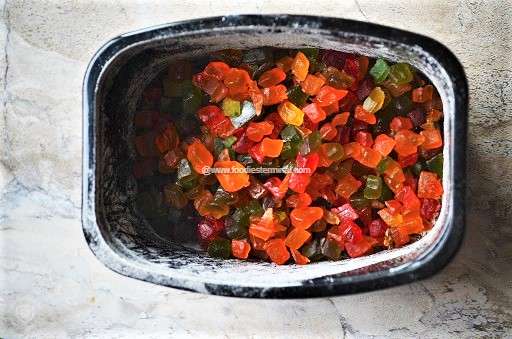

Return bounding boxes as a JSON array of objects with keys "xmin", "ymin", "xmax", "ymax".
[{"xmin": 0, "ymin": 0, "xmax": 512, "ymax": 338}]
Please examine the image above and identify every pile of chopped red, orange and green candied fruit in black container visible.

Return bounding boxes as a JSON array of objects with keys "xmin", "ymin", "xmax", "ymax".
[{"xmin": 133, "ymin": 48, "xmax": 443, "ymax": 265}]
